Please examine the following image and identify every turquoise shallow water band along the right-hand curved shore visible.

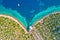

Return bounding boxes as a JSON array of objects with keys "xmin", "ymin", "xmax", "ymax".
[{"xmin": 30, "ymin": 6, "xmax": 60, "ymax": 25}]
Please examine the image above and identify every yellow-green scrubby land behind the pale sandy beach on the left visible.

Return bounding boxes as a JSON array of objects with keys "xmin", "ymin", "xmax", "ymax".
[{"xmin": 0, "ymin": 17, "xmax": 34, "ymax": 40}]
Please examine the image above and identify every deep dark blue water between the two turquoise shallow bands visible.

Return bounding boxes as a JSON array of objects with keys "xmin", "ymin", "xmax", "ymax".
[{"xmin": 0, "ymin": 0, "xmax": 60, "ymax": 29}]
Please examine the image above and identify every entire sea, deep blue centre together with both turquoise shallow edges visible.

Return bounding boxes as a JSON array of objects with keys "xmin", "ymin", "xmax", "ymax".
[{"xmin": 0, "ymin": 0, "xmax": 60, "ymax": 30}]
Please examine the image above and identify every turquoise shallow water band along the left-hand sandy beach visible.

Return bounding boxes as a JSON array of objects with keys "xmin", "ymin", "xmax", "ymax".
[{"xmin": 0, "ymin": 5, "xmax": 27, "ymax": 28}]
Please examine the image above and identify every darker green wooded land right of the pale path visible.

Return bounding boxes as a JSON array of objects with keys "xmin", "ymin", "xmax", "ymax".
[{"xmin": 35, "ymin": 13, "xmax": 60, "ymax": 40}]
